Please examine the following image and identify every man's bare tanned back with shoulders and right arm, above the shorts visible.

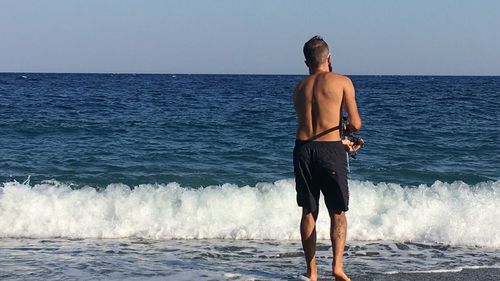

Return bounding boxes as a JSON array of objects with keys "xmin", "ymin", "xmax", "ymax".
[{"xmin": 293, "ymin": 72, "xmax": 361, "ymax": 141}]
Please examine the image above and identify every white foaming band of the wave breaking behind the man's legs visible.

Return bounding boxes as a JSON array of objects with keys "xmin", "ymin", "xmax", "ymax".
[{"xmin": 0, "ymin": 180, "xmax": 500, "ymax": 247}]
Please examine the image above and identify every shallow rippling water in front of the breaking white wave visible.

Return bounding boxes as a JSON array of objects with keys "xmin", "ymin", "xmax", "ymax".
[{"xmin": 0, "ymin": 238, "xmax": 500, "ymax": 280}]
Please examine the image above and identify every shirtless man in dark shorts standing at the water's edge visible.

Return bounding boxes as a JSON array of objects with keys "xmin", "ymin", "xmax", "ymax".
[{"xmin": 293, "ymin": 36, "xmax": 361, "ymax": 281}]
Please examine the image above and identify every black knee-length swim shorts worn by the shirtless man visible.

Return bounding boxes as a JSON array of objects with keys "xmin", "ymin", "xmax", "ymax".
[{"xmin": 293, "ymin": 140, "xmax": 349, "ymax": 212}]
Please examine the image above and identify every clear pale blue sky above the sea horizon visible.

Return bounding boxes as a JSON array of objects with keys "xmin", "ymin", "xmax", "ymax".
[{"xmin": 0, "ymin": 0, "xmax": 500, "ymax": 75}]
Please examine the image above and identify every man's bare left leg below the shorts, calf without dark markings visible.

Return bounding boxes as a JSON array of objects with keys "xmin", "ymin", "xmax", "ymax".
[{"xmin": 300, "ymin": 208, "xmax": 318, "ymax": 281}]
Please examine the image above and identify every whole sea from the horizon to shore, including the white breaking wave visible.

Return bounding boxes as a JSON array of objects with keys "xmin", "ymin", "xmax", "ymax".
[{"xmin": 0, "ymin": 73, "xmax": 500, "ymax": 280}]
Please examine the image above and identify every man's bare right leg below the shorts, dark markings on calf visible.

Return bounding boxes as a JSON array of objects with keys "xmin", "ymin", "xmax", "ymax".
[{"xmin": 328, "ymin": 210, "xmax": 350, "ymax": 281}]
